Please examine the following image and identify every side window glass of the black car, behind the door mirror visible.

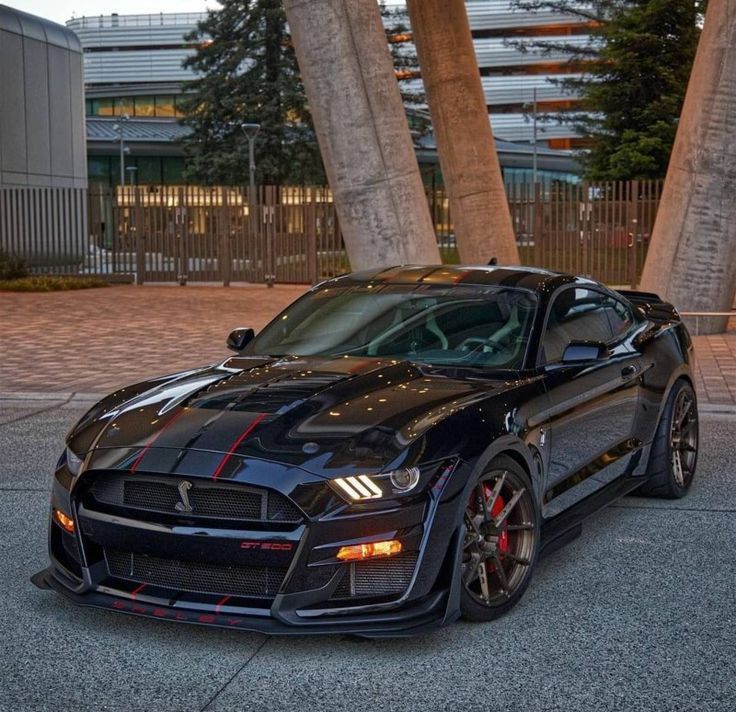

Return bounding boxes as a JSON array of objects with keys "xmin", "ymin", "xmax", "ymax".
[{"xmin": 541, "ymin": 287, "xmax": 620, "ymax": 363}]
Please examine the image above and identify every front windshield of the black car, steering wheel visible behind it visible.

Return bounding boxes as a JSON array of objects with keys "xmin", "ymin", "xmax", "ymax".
[{"xmin": 245, "ymin": 283, "xmax": 536, "ymax": 369}]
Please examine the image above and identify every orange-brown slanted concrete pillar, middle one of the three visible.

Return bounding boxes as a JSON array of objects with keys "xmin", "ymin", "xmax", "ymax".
[{"xmin": 408, "ymin": 0, "xmax": 519, "ymax": 264}]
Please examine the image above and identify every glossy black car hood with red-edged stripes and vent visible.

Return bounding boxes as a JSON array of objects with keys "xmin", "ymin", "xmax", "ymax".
[{"xmin": 69, "ymin": 357, "xmax": 510, "ymax": 477}]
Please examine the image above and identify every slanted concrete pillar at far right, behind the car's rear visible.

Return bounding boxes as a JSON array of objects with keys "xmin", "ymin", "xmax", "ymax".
[{"xmin": 641, "ymin": 0, "xmax": 736, "ymax": 333}]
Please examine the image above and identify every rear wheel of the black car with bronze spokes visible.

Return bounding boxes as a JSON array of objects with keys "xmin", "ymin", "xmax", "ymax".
[{"xmin": 636, "ymin": 380, "xmax": 698, "ymax": 499}]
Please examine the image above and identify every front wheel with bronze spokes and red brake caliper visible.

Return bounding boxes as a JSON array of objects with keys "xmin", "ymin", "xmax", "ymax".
[{"xmin": 459, "ymin": 455, "xmax": 540, "ymax": 621}]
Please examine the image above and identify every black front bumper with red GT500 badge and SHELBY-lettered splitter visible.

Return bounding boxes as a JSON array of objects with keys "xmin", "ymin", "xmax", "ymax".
[{"xmin": 32, "ymin": 454, "xmax": 460, "ymax": 637}]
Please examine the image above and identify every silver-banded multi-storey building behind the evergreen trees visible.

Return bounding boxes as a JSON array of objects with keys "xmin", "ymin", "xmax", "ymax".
[{"xmin": 67, "ymin": 0, "xmax": 591, "ymax": 185}]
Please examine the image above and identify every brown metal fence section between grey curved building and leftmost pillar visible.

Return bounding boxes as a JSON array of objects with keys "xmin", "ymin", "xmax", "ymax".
[{"xmin": 83, "ymin": 186, "xmax": 348, "ymax": 284}]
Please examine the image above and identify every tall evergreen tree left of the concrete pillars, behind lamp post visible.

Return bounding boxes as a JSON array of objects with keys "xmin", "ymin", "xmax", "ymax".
[{"xmin": 183, "ymin": 0, "xmax": 324, "ymax": 185}]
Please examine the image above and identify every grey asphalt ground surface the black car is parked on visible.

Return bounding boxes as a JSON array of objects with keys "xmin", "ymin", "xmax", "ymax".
[{"xmin": 0, "ymin": 400, "xmax": 736, "ymax": 712}]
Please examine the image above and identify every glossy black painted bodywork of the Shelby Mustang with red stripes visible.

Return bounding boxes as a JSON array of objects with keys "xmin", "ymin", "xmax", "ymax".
[{"xmin": 34, "ymin": 267, "xmax": 692, "ymax": 636}]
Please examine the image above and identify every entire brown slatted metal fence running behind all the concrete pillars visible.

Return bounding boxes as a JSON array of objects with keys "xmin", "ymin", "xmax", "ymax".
[{"xmin": 0, "ymin": 181, "xmax": 661, "ymax": 285}]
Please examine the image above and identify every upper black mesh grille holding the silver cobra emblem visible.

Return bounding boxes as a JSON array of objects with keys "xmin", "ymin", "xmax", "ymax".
[{"xmin": 91, "ymin": 475, "xmax": 302, "ymax": 523}]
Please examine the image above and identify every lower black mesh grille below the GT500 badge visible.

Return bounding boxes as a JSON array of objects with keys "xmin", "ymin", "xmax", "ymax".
[{"xmin": 105, "ymin": 549, "xmax": 287, "ymax": 598}]
